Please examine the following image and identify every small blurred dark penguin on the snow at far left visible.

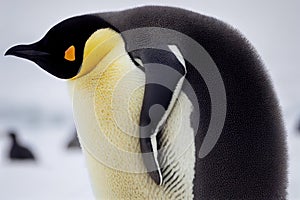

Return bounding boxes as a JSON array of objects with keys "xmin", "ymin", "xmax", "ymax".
[{"xmin": 8, "ymin": 131, "xmax": 35, "ymax": 160}]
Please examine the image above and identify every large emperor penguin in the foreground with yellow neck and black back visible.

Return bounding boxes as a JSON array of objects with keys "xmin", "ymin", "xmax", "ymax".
[{"xmin": 6, "ymin": 6, "xmax": 287, "ymax": 200}]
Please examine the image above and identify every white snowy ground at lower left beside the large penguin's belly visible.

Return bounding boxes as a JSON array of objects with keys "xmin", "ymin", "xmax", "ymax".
[{"xmin": 0, "ymin": 126, "xmax": 93, "ymax": 200}]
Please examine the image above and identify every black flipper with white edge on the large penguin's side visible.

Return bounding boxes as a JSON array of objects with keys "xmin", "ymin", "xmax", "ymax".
[{"xmin": 132, "ymin": 46, "xmax": 186, "ymax": 185}]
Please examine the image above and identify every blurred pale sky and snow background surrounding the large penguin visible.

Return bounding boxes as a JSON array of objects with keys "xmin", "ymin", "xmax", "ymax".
[{"xmin": 0, "ymin": 0, "xmax": 300, "ymax": 200}]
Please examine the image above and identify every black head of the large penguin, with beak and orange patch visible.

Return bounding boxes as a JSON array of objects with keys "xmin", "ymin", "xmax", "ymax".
[{"xmin": 5, "ymin": 15, "xmax": 114, "ymax": 79}]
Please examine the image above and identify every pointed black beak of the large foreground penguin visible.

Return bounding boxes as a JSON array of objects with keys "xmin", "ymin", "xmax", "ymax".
[{"xmin": 4, "ymin": 44, "xmax": 50, "ymax": 59}]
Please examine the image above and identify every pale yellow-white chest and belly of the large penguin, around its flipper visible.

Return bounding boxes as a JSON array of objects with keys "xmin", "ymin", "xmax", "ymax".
[{"xmin": 70, "ymin": 52, "xmax": 195, "ymax": 199}]
